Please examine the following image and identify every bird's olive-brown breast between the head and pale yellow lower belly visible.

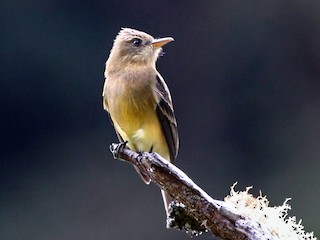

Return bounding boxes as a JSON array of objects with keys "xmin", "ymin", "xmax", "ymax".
[{"xmin": 106, "ymin": 68, "xmax": 157, "ymax": 134}]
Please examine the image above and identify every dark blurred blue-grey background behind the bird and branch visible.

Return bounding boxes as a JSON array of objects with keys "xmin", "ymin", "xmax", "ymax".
[{"xmin": 0, "ymin": 0, "xmax": 320, "ymax": 240}]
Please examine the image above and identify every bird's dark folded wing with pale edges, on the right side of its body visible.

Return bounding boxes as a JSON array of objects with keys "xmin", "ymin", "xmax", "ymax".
[{"xmin": 156, "ymin": 73, "xmax": 179, "ymax": 161}]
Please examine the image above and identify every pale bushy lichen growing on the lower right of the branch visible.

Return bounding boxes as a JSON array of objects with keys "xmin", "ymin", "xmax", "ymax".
[{"xmin": 225, "ymin": 183, "xmax": 317, "ymax": 240}]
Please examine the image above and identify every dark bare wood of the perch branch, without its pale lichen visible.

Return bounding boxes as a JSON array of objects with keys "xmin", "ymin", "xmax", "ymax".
[{"xmin": 110, "ymin": 144, "xmax": 316, "ymax": 240}]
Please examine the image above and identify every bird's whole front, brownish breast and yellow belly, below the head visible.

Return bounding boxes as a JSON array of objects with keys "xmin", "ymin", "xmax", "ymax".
[{"xmin": 104, "ymin": 68, "xmax": 170, "ymax": 160}]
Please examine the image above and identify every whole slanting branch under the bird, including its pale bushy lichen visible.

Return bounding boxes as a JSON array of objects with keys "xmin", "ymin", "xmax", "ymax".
[{"xmin": 110, "ymin": 143, "xmax": 316, "ymax": 240}]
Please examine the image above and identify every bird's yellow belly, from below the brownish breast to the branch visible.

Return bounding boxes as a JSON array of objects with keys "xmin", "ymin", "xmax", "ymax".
[{"xmin": 109, "ymin": 89, "xmax": 170, "ymax": 161}]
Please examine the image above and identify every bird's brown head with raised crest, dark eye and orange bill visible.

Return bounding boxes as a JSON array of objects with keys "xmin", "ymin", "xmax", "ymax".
[{"xmin": 110, "ymin": 28, "xmax": 173, "ymax": 65}]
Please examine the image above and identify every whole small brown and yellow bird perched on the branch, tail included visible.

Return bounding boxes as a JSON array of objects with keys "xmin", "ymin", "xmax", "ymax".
[{"xmin": 102, "ymin": 28, "xmax": 179, "ymax": 216}]
